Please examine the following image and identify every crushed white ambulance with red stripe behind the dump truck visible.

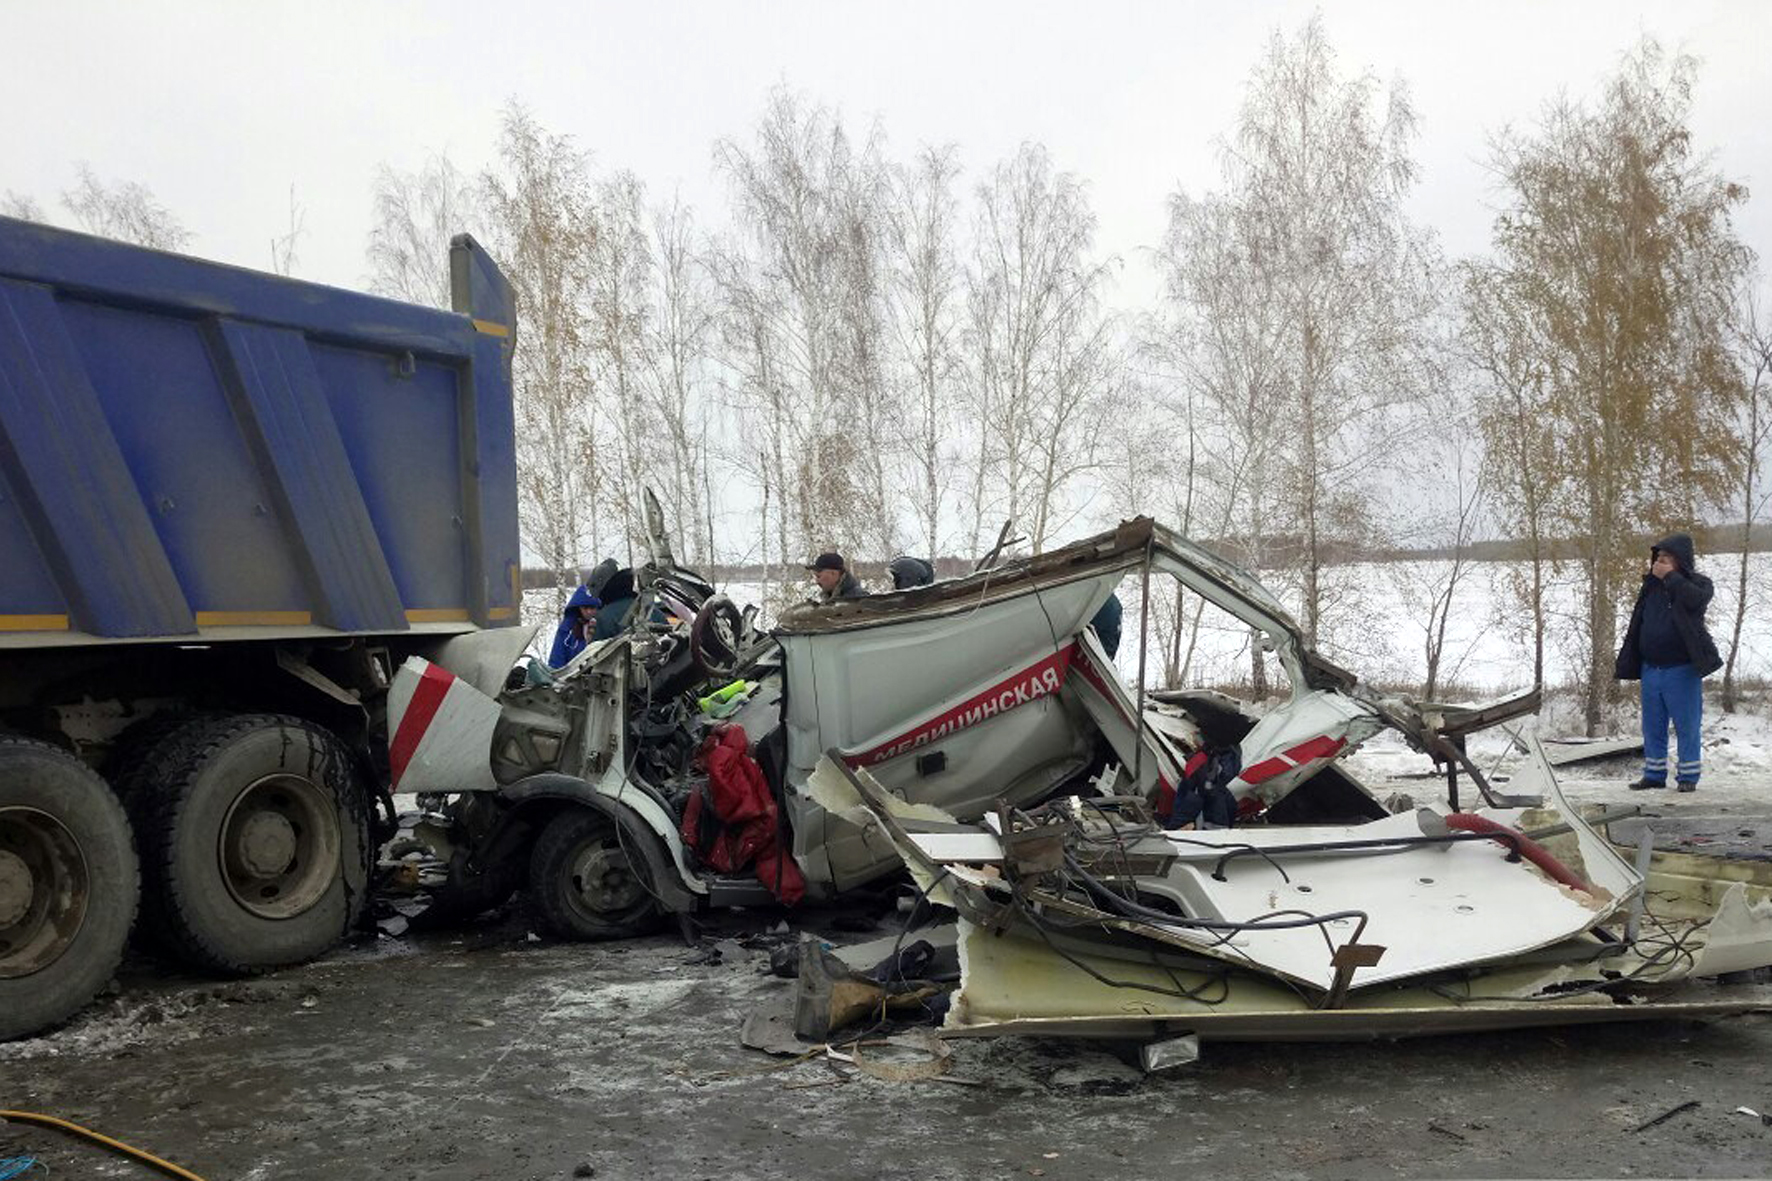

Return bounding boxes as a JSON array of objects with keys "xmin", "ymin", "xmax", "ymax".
[{"xmin": 388, "ymin": 512, "xmax": 1535, "ymax": 938}]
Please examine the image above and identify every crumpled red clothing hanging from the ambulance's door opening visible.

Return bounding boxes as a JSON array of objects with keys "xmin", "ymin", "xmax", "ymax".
[{"xmin": 682, "ymin": 725, "xmax": 806, "ymax": 906}]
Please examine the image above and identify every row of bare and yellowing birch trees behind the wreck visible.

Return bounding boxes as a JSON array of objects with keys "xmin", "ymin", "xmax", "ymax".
[{"xmin": 0, "ymin": 18, "xmax": 1772, "ymax": 729}]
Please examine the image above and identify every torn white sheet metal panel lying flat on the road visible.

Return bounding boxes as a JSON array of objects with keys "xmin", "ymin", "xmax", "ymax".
[{"xmin": 838, "ymin": 750, "xmax": 1772, "ymax": 1041}]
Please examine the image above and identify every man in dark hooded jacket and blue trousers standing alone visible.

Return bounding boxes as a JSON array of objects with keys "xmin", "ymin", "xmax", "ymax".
[{"xmin": 1616, "ymin": 534, "xmax": 1722, "ymax": 791}]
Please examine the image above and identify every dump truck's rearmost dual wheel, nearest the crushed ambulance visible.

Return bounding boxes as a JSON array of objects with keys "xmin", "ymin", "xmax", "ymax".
[{"xmin": 133, "ymin": 715, "xmax": 374, "ymax": 974}]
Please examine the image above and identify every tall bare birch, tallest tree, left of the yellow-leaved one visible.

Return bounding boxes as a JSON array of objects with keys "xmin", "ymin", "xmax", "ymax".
[{"xmin": 1223, "ymin": 18, "xmax": 1437, "ymax": 644}]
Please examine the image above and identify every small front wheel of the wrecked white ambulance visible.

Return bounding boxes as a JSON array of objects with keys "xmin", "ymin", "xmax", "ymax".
[{"xmin": 530, "ymin": 805, "xmax": 665, "ymax": 940}]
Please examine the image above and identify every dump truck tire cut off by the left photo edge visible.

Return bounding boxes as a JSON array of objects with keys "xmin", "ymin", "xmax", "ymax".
[{"xmin": 0, "ymin": 736, "xmax": 140, "ymax": 1041}]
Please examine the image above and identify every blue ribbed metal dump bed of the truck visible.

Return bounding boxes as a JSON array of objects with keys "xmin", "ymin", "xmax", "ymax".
[{"xmin": 0, "ymin": 218, "xmax": 519, "ymax": 651}]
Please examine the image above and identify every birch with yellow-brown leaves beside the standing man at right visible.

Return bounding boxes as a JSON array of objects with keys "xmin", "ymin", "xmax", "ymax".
[{"xmin": 1494, "ymin": 41, "xmax": 1749, "ymax": 734}]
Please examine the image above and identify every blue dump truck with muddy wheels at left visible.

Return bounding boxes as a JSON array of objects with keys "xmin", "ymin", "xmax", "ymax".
[{"xmin": 0, "ymin": 218, "xmax": 521, "ymax": 1039}]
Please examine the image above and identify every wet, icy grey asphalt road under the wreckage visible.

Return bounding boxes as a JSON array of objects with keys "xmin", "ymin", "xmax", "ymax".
[{"xmin": 0, "ymin": 758, "xmax": 1772, "ymax": 1181}]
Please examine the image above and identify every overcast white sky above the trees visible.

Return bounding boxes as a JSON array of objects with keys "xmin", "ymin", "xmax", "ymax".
[{"xmin": 0, "ymin": 0, "xmax": 1772, "ymax": 303}]
